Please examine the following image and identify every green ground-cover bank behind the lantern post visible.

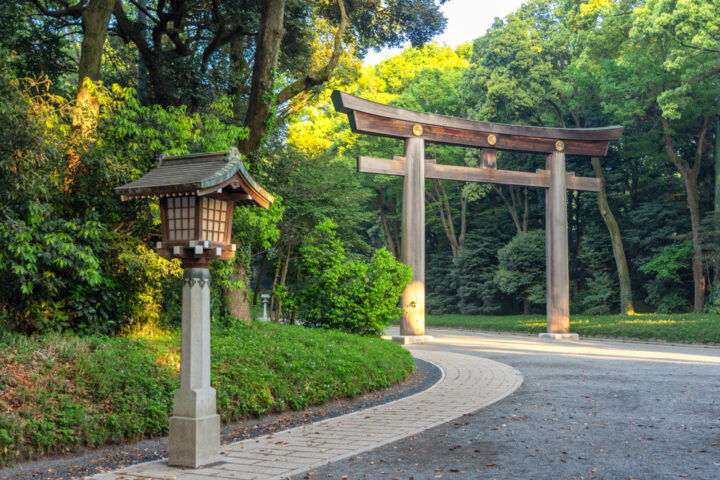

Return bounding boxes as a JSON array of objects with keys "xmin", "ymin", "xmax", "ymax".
[{"xmin": 0, "ymin": 322, "xmax": 414, "ymax": 468}]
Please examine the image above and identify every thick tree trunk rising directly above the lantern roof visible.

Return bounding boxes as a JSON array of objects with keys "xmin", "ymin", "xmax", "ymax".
[{"xmin": 239, "ymin": 0, "xmax": 285, "ymax": 155}]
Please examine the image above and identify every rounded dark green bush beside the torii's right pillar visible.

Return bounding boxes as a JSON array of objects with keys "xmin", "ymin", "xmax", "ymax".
[{"xmin": 495, "ymin": 230, "xmax": 546, "ymax": 304}]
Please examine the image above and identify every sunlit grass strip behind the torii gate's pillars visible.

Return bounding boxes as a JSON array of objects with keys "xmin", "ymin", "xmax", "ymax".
[{"xmin": 425, "ymin": 313, "xmax": 720, "ymax": 343}]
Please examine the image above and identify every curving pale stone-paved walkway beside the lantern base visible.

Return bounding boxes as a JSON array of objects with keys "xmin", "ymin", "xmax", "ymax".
[{"xmin": 92, "ymin": 350, "xmax": 523, "ymax": 480}]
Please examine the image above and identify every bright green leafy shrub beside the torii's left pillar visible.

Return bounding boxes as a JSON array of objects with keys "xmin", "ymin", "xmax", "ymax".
[{"xmin": 286, "ymin": 220, "xmax": 412, "ymax": 335}]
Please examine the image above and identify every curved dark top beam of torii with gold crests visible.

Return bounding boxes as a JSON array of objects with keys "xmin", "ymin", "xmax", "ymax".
[{"xmin": 332, "ymin": 90, "xmax": 623, "ymax": 156}]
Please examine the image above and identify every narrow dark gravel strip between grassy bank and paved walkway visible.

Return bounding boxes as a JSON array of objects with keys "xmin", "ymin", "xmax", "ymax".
[{"xmin": 0, "ymin": 359, "xmax": 442, "ymax": 480}]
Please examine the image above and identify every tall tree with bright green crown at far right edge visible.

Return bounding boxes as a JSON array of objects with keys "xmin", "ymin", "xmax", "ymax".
[{"xmin": 588, "ymin": 0, "xmax": 720, "ymax": 312}]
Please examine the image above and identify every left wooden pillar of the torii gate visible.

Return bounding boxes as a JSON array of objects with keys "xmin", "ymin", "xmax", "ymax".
[{"xmin": 395, "ymin": 137, "xmax": 427, "ymax": 343}]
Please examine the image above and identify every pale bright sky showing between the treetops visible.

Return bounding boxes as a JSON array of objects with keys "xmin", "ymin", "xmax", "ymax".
[{"xmin": 364, "ymin": 0, "xmax": 523, "ymax": 65}]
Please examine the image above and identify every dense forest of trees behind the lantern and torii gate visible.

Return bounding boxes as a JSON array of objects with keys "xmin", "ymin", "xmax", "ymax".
[{"xmin": 0, "ymin": 0, "xmax": 720, "ymax": 333}]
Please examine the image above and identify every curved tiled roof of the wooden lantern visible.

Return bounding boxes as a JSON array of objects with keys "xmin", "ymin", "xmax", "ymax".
[{"xmin": 115, "ymin": 148, "xmax": 275, "ymax": 208}]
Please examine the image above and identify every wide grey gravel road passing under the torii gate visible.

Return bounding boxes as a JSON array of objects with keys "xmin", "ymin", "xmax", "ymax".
[{"xmin": 293, "ymin": 330, "xmax": 720, "ymax": 480}]
